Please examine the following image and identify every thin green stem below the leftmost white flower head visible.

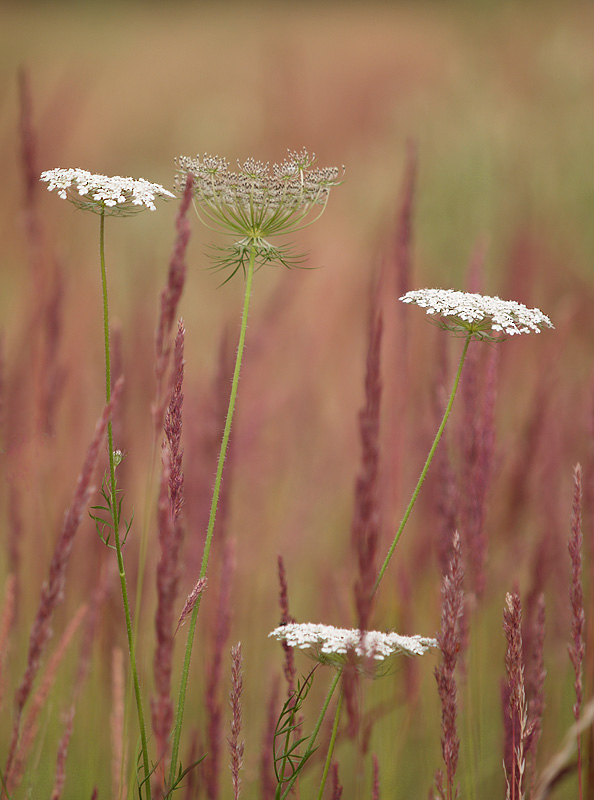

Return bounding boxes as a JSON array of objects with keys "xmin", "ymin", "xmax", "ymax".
[{"xmin": 99, "ymin": 210, "xmax": 151, "ymax": 800}]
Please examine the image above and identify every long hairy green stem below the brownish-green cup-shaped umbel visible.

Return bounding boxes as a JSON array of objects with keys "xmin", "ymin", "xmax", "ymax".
[{"xmin": 169, "ymin": 249, "xmax": 256, "ymax": 787}]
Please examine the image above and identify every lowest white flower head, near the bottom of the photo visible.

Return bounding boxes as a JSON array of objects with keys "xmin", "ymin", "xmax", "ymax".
[{"xmin": 268, "ymin": 622, "xmax": 437, "ymax": 673}]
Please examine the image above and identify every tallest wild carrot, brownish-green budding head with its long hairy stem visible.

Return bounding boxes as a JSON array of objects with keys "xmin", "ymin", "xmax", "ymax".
[{"xmin": 169, "ymin": 150, "xmax": 340, "ymax": 786}]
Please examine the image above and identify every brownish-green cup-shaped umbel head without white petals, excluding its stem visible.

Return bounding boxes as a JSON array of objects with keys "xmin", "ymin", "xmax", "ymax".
[{"xmin": 176, "ymin": 149, "xmax": 341, "ymax": 280}]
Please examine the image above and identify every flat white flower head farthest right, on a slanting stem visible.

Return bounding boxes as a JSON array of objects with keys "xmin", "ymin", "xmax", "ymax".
[{"xmin": 400, "ymin": 289, "xmax": 554, "ymax": 341}]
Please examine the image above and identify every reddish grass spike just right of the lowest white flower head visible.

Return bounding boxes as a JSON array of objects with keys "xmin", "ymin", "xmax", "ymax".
[{"xmin": 435, "ymin": 531, "xmax": 464, "ymax": 800}]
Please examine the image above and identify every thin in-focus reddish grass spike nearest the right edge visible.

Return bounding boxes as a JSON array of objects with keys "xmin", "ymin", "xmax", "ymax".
[{"xmin": 568, "ymin": 464, "xmax": 586, "ymax": 800}]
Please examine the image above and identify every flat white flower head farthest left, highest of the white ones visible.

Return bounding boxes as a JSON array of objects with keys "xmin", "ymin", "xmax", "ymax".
[{"xmin": 40, "ymin": 169, "xmax": 175, "ymax": 215}]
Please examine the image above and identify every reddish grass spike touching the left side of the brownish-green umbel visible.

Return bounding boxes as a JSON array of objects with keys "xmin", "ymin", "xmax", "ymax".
[{"xmin": 153, "ymin": 175, "xmax": 194, "ymax": 431}]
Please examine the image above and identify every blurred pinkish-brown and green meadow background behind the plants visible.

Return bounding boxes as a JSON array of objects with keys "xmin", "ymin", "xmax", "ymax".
[{"xmin": 0, "ymin": 2, "xmax": 594, "ymax": 800}]
